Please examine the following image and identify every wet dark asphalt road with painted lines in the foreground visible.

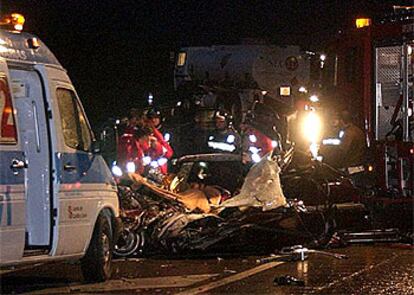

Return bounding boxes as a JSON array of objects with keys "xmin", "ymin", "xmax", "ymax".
[{"xmin": 1, "ymin": 244, "xmax": 414, "ymax": 294}]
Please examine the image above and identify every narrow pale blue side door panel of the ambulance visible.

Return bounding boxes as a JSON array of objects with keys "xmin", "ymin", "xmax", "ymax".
[{"xmin": 9, "ymin": 64, "xmax": 52, "ymax": 251}]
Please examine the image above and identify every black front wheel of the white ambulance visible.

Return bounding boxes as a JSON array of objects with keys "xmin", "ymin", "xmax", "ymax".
[{"xmin": 81, "ymin": 212, "xmax": 114, "ymax": 282}]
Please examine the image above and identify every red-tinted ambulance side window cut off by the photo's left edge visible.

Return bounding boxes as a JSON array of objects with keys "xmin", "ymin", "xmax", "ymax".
[{"xmin": 0, "ymin": 77, "xmax": 17, "ymax": 144}]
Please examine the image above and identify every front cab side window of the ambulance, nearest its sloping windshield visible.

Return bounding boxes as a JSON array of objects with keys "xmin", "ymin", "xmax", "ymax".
[{"xmin": 56, "ymin": 88, "xmax": 92, "ymax": 151}]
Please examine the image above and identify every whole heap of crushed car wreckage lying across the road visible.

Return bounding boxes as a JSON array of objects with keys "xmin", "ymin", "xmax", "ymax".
[{"xmin": 115, "ymin": 153, "xmax": 372, "ymax": 257}]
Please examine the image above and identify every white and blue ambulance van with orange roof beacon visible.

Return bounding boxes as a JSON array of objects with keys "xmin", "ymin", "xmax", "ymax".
[{"xmin": 0, "ymin": 15, "xmax": 120, "ymax": 281}]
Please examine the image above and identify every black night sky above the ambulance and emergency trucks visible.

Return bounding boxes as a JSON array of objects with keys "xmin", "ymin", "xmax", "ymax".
[{"xmin": 0, "ymin": 0, "xmax": 412, "ymax": 127}]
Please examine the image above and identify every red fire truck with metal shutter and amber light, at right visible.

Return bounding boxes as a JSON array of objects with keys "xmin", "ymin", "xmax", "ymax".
[{"xmin": 322, "ymin": 7, "xmax": 414, "ymax": 199}]
